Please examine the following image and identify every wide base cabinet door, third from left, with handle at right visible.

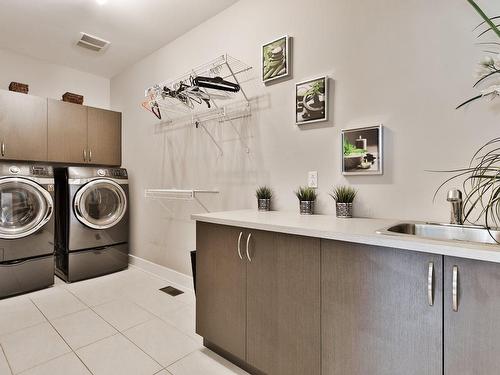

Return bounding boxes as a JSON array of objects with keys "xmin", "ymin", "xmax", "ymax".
[{"xmin": 321, "ymin": 240, "xmax": 442, "ymax": 375}]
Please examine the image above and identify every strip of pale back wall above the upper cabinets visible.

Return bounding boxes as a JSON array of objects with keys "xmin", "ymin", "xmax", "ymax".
[{"xmin": 0, "ymin": 50, "xmax": 110, "ymax": 108}]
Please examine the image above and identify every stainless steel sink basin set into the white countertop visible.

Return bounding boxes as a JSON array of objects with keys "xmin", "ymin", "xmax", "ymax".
[{"xmin": 377, "ymin": 222, "xmax": 500, "ymax": 245}]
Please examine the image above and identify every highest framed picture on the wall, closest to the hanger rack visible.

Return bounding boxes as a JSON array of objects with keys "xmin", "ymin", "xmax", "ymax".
[{"xmin": 262, "ymin": 35, "xmax": 291, "ymax": 83}]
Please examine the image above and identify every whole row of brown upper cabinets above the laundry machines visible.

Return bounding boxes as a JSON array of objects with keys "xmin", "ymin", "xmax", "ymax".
[{"xmin": 0, "ymin": 90, "xmax": 122, "ymax": 166}]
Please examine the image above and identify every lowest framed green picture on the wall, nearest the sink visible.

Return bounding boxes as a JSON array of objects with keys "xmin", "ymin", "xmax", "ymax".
[{"xmin": 341, "ymin": 125, "xmax": 384, "ymax": 175}]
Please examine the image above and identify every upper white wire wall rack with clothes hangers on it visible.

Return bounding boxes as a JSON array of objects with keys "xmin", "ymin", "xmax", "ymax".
[{"xmin": 142, "ymin": 54, "xmax": 252, "ymax": 126}]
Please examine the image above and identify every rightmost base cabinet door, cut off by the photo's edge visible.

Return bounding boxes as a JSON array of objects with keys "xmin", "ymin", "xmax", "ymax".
[{"xmin": 444, "ymin": 257, "xmax": 500, "ymax": 375}]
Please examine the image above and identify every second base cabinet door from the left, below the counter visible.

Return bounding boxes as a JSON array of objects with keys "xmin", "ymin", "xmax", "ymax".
[{"xmin": 247, "ymin": 230, "xmax": 321, "ymax": 375}]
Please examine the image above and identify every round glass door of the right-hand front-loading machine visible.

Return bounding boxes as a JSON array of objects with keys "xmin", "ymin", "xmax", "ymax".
[{"xmin": 73, "ymin": 179, "xmax": 127, "ymax": 229}]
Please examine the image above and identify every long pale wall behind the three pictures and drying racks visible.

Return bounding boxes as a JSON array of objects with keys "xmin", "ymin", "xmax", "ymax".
[{"xmin": 111, "ymin": 0, "xmax": 500, "ymax": 274}]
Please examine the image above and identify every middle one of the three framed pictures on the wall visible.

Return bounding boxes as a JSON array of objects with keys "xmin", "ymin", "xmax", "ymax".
[{"xmin": 295, "ymin": 76, "xmax": 328, "ymax": 125}]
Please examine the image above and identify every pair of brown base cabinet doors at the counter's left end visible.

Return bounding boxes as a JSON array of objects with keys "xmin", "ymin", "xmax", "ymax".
[{"xmin": 196, "ymin": 222, "xmax": 321, "ymax": 375}]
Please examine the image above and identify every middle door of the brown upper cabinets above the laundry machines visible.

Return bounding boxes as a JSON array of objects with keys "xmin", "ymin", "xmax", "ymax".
[{"xmin": 48, "ymin": 99, "xmax": 88, "ymax": 163}]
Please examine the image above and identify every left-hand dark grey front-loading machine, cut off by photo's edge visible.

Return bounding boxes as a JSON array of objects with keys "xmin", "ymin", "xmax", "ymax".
[{"xmin": 0, "ymin": 162, "xmax": 54, "ymax": 298}]
